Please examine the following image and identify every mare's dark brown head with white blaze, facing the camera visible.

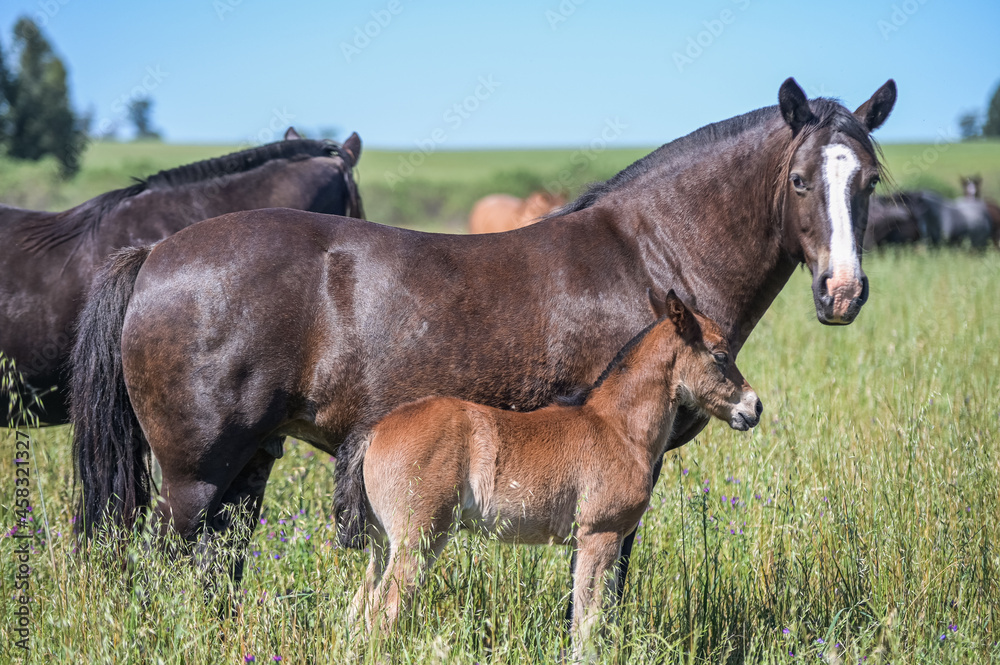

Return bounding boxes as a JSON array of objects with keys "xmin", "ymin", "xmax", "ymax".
[{"xmin": 778, "ymin": 78, "xmax": 896, "ymax": 325}]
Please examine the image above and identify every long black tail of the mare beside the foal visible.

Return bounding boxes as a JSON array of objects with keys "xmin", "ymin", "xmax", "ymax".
[{"xmin": 70, "ymin": 247, "xmax": 152, "ymax": 538}]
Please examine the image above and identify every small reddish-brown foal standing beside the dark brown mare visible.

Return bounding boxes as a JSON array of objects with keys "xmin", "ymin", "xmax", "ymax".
[{"xmin": 352, "ymin": 291, "xmax": 763, "ymax": 658}]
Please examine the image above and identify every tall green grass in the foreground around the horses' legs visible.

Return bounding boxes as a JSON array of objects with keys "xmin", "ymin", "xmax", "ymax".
[{"xmin": 0, "ymin": 246, "xmax": 1000, "ymax": 664}]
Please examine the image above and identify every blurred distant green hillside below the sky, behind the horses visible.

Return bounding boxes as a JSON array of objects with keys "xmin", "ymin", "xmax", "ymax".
[{"xmin": 0, "ymin": 141, "xmax": 1000, "ymax": 230}]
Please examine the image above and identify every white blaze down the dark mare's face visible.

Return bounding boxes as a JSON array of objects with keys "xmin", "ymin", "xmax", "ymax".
[{"xmin": 823, "ymin": 143, "xmax": 861, "ymax": 277}]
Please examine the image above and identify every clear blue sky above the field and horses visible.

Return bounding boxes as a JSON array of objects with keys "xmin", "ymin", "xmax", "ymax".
[{"xmin": 0, "ymin": 0, "xmax": 1000, "ymax": 149}]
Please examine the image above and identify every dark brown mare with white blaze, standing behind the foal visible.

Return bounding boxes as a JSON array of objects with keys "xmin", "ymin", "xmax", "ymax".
[{"xmin": 72, "ymin": 79, "xmax": 896, "ymax": 600}]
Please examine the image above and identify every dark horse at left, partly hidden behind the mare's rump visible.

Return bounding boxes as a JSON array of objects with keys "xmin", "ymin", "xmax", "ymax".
[{"xmin": 0, "ymin": 129, "xmax": 363, "ymax": 425}]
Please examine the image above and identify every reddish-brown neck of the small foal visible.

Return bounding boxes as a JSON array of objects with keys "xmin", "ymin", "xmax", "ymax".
[{"xmin": 583, "ymin": 320, "xmax": 683, "ymax": 469}]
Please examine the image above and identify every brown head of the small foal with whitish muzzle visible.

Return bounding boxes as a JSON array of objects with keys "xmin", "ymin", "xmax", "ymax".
[{"xmin": 650, "ymin": 289, "xmax": 764, "ymax": 431}]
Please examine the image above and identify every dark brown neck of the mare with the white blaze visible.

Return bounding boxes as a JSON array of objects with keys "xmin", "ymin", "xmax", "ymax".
[{"xmin": 595, "ymin": 119, "xmax": 798, "ymax": 353}]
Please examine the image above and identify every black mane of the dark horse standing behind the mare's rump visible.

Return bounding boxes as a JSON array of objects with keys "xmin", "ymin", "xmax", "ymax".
[{"xmin": 23, "ymin": 139, "xmax": 364, "ymax": 252}]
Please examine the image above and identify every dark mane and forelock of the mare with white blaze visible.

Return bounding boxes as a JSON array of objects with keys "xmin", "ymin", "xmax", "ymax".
[{"xmin": 546, "ymin": 97, "xmax": 875, "ymax": 219}]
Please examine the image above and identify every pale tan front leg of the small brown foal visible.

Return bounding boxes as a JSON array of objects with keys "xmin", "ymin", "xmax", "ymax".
[{"xmin": 571, "ymin": 532, "xmax": 622, "ymax": 662}]
